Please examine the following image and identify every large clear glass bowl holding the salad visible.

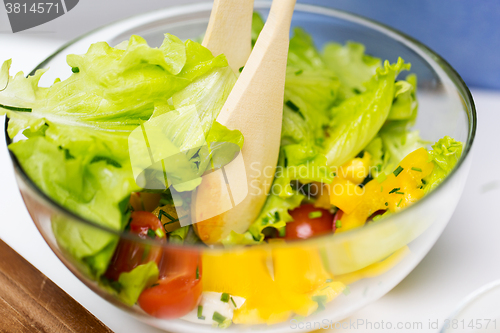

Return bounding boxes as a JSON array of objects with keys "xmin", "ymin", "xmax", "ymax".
[{"xmin": 7, "ymin": 2, "xmax": 476, "ymax": 332}]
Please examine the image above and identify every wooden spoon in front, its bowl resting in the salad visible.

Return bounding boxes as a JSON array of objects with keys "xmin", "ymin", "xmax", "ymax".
[{"xmin": 192, "ymin": 0, "xmax": 295, "ymax": 244}]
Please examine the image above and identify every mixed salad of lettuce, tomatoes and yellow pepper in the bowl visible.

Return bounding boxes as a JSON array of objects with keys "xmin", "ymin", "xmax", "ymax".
[{"xmin": 0, "ymin": 15, "xmax": 462, "ymax": 328}]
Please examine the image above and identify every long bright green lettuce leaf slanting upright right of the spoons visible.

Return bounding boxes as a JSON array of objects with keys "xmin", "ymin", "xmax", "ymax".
[{"xmin": 325, "ymin": 58, "xmax": 410, "ymax": 166}]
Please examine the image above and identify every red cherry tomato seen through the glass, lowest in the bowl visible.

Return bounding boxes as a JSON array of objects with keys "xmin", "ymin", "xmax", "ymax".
[{"xmin": 138, "ymin": 248, "xmax": 202, "ymax": 319}]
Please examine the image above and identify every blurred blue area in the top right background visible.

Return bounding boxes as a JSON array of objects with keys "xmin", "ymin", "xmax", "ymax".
[{"xmin": 298, "ymin": 0, "xmax": 500, "ymax": 89}]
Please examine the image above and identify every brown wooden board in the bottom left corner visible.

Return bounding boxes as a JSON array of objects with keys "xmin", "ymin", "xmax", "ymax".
[{"xmin": 0, "ymin": 240, "xmax": 112, "ymax": 333}]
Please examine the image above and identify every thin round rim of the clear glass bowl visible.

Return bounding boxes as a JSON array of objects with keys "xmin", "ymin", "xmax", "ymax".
[{"xmin": 5, "ymin": 1, "xmax": 477, "ymax": 251}]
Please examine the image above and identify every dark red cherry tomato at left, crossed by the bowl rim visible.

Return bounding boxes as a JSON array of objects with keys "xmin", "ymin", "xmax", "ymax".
[{"xmin": 104, "ymin": 211, "xmax": 166, "ymax": 281}]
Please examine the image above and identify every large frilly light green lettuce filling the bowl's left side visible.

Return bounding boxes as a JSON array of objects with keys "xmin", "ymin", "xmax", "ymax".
[{"xmin": 0, "ymin": 34, "xmax": 237, "ymax": 277}]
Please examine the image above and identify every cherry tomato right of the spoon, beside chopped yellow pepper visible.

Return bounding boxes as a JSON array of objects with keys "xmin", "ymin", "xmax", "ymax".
[{"xmin": 284, "ymin": 204, "xmax": 334, "ymax": 239}]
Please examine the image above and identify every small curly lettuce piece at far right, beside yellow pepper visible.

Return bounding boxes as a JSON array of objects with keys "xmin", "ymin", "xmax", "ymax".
[{"xmin": 424, "ymin": 136, "xmax": 463, "ymax": 193}]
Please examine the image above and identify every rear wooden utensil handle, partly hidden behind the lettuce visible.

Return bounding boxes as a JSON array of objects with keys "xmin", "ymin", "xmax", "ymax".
[{"xmin": 202, "ymin": 0, "xmax": 253, "ymax": 74}]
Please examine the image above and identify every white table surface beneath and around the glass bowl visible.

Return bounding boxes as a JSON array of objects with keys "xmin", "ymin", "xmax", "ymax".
[{"xmin": 0, "ymin": 34, "xmax": 500, "ymax": 333}]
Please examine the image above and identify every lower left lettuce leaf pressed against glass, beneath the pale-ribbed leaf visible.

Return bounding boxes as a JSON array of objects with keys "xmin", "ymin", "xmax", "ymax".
[{"xmin": 9, "ymin": 134, "xmax": 135, "ymax": 276}]
